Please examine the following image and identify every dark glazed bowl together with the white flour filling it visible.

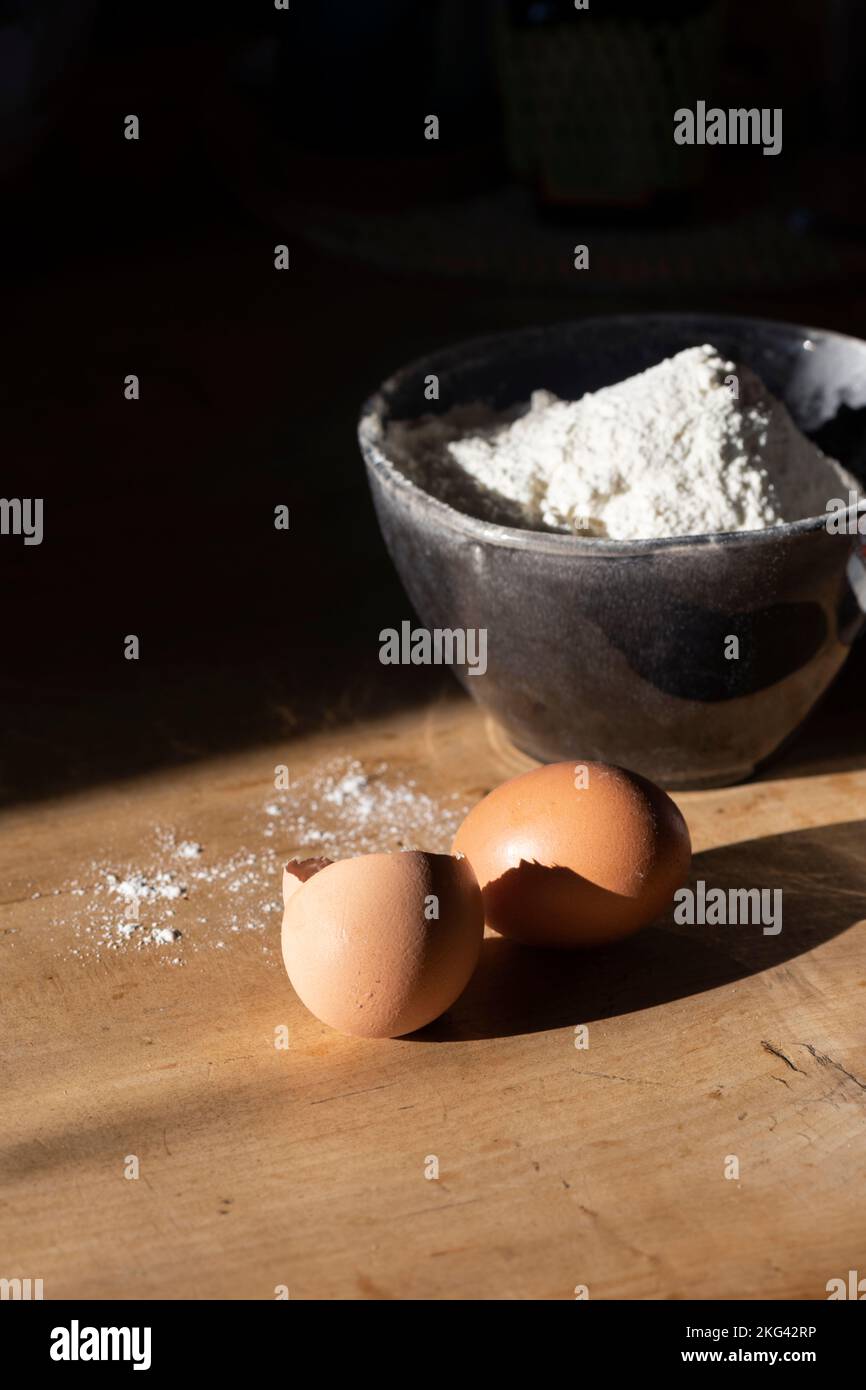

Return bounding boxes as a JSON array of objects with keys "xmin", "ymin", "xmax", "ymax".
[{"xmin": 360, "ymin": 314, "xmax": 866, "ymax": 787}]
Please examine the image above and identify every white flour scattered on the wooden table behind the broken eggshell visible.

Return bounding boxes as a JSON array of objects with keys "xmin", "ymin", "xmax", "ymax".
[{"xmin": 53, "ymin": 758, "xmax": 468, "ymax": 965}]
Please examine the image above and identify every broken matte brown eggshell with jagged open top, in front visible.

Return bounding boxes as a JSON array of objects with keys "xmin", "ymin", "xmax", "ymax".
[{"xmin": 282, "ymin": 851, "xmax": 484, "ymax": 1038}]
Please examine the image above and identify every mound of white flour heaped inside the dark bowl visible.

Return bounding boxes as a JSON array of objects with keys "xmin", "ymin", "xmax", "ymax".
[{"xmin": 388, "ymin": 343, "xmax": 849, "ymax": 539}]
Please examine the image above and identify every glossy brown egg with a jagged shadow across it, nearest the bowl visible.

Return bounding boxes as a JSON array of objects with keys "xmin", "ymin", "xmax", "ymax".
[{"xmin": 452, "ymin": 763, "xmax": 691, "ymax": 947}]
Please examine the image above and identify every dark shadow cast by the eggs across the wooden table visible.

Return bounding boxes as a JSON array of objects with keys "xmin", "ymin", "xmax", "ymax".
[{"xmin": 414, "ymin": 820, "xmax": 866, "ymax": 1043}]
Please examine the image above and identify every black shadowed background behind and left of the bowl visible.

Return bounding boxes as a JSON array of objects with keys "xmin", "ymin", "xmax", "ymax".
[{"xmin": 0, "ymin": 0, "xmax": 866, "ymax": 801}]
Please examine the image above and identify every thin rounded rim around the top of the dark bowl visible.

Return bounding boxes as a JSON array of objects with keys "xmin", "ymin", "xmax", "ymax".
[{"xmin": 357, "ymin": 310, "xmax": 866, "ymax": 557}]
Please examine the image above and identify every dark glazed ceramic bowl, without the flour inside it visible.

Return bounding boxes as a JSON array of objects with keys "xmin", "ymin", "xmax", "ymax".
[{"xmin": 360, "ymin": 314, "xmax": 866, "ymax": 787}]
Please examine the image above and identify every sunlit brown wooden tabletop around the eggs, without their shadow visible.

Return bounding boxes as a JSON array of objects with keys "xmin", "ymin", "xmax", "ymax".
[{"xmin": 0, "ymin": 695, "xmax": 866, "ymax": 1300}]
